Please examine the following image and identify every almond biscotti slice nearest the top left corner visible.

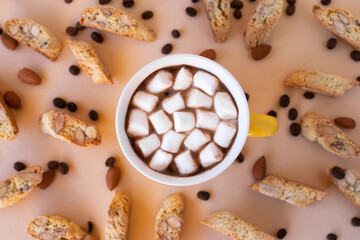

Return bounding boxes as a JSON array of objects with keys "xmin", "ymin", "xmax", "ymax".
[{"xmin": 3, "ymin": 19, "xmax": 62, "ymax": 62}]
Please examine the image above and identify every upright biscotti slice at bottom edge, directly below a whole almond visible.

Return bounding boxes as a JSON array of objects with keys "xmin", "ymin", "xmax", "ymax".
[{"xmin": 105, "ymin": 190, "xmax": 130, "ymax": 240}]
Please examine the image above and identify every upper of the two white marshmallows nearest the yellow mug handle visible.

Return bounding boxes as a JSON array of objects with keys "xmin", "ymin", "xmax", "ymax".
[{"xmin": 214, "ymin": 92, "xmax": 237, "ymax": 119}]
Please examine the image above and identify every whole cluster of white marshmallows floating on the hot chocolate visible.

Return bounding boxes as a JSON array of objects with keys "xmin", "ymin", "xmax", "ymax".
[{"xmin": 127, "ymin": 67, "xmax": 237, "ymax": 175}]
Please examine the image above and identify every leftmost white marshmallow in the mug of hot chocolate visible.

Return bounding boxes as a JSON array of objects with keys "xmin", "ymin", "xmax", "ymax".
[{"xmin": 127, "ymin": 109, "xmax": 149, "ymax": 137}]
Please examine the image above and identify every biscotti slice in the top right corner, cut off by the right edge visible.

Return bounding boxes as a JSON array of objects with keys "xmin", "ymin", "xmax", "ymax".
[{"xmin": 312, "ymin": 5, "xmax": 360, "ymax": 50}]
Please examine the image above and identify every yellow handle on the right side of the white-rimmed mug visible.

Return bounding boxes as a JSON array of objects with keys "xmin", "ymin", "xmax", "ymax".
[{"xmin": 248, "ymin": 114, "xmax": 278, "ymax": 137}]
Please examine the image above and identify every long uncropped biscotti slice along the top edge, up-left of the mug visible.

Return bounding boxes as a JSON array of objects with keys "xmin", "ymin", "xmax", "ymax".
[{"xmin": 80, "ymin": 6, "xmax": 156, "ymax": 41}]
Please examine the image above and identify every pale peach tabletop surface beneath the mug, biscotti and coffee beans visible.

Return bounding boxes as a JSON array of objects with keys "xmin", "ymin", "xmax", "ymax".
[{"xmin": 0, "ymin": 0, "xmax": 360, "ymax": 240}]
